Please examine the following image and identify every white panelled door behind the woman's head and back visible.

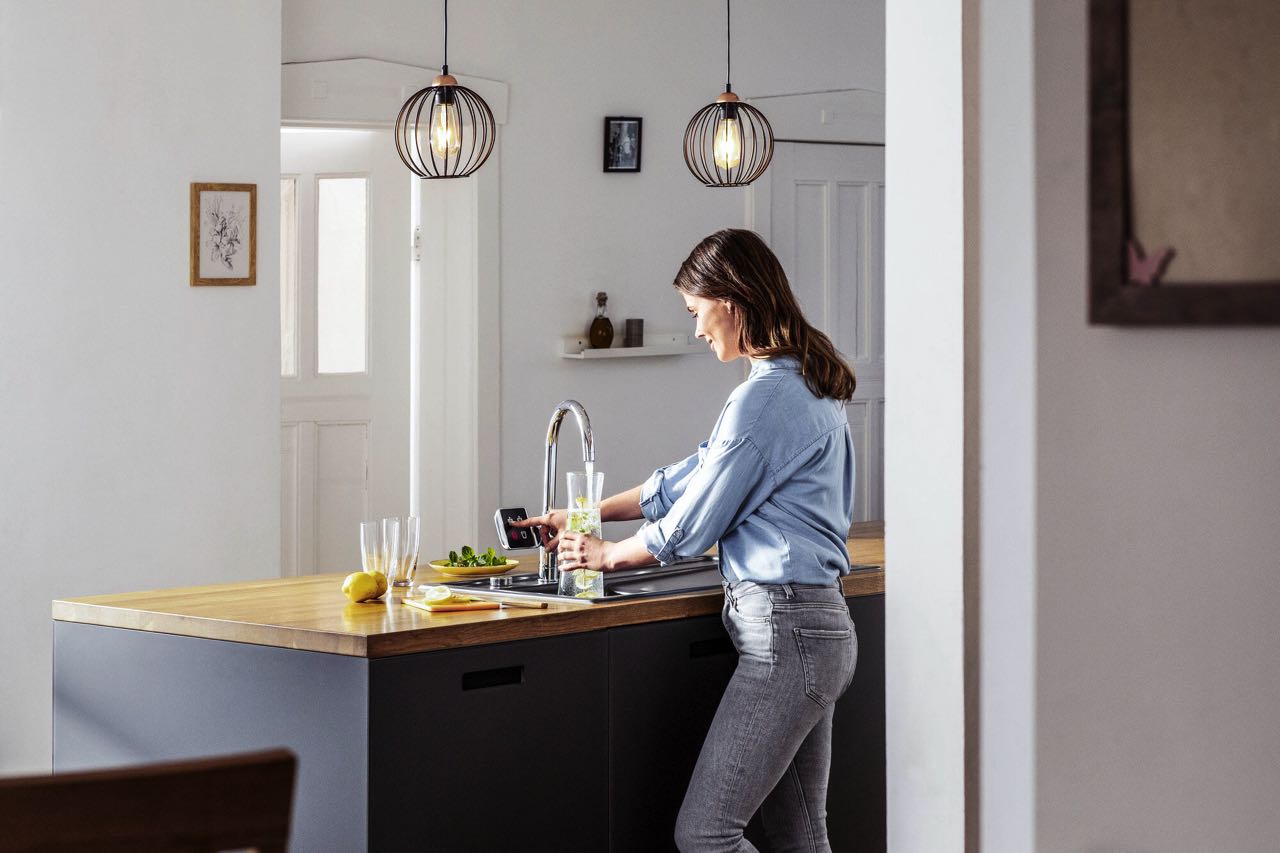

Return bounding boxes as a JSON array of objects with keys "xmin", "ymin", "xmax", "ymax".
[{"xmin": 753, "ymin": 142, "xmax": 884, "ymax": 521}]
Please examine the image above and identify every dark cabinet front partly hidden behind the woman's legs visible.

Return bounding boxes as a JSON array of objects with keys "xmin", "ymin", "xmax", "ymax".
[{"xmin": 609, "ymin": 596, "xmax": 886, "ymax": 853}]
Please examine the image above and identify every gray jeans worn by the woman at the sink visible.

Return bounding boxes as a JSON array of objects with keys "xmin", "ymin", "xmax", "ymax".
[{"xmin": 676, "ymin": 581, "xmax": 858, "ymax": 853}]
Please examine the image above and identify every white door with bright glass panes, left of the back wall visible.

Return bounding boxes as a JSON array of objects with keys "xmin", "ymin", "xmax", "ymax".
[{"xmin": 280, "ymin": 128, "xmax": 412, "ymax": 575}]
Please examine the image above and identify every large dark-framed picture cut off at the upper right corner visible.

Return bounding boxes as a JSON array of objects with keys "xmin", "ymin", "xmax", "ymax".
[{"xmin": 1088, "ymin": 0, "xmax": 1280, "ymax": 327}]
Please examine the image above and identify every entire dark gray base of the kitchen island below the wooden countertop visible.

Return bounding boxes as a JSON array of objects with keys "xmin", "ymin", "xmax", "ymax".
[{"xmin": 54, "ymin": 596, "xmax": 884, "ymax": 853}]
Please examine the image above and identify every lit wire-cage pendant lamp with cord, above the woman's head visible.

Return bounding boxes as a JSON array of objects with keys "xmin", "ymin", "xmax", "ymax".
[{"xmin": 685, "ymin": 0, "xmax": 773, "ymax": 187}]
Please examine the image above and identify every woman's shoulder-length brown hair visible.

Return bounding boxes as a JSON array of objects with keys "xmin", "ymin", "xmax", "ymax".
[{"xmin": 673, "ymin": 228, "xmax": 858, "ymax": 401}]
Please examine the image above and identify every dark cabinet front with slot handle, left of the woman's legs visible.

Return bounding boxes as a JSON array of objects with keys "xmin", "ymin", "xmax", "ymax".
[{"xmin": 369, "ymin": 631, "xmax": 609, "ymax": 853}]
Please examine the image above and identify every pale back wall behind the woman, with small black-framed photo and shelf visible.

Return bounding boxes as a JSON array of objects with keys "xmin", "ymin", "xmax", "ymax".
[{"xmin": 284, "ymin": 0, "xmax": 884, "ymax": 534}]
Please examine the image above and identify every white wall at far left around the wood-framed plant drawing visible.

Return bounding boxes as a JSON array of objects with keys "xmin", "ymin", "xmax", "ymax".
[{"xmin": 0, "ymin": 0, "xmax": 280, "ymax": 772}]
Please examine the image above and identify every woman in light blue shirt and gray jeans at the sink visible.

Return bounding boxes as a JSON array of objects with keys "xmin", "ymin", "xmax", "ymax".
[{"xmin": 514, "ymin": 229, "xmax": 858, "ymax": 853}]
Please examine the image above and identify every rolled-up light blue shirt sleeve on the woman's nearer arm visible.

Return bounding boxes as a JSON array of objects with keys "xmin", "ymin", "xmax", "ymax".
[{"xmin": 637, "ymin": 437, "xmax": 774, "ymax": 562}]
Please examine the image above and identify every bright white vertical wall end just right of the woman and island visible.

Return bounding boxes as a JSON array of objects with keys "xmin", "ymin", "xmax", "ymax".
[{"xmin": 884, "ymin": 0, "xmax": 965, "ymax": 853}]
